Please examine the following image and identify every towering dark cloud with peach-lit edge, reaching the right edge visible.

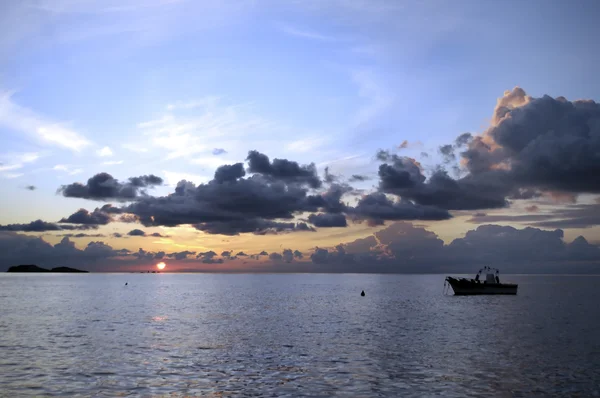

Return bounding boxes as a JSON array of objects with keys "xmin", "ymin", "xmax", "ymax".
[{"xmin": 376, "ymin": 87, "xmax": 600, "ymax": 219}]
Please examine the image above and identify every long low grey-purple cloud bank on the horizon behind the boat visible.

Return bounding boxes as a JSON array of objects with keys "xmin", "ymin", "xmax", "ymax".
[{"xmin": 304, "ymin": 222, "xmax": 600, "ymax": 273}]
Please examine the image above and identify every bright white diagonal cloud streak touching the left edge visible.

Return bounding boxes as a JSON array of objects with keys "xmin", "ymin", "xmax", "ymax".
[{"xmin": 0, "ymin": 92, "xmax": 91, "ymax": 152}]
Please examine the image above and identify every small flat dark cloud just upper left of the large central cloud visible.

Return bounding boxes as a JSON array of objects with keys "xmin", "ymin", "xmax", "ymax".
[{"xmin": 58, "ymin": 173, "xmax": 163, "ymax": 201}]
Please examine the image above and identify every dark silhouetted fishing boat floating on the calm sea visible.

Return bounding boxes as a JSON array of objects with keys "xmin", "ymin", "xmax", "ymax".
[{"xmin": 444, "ymin": 266, "xmax": 519, "ymax": 296}]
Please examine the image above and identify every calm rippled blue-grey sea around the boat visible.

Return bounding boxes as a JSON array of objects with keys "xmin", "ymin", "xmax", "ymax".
[{"xmin": 0, "ymin": 274, "xmax": 600, "ymax": 397}]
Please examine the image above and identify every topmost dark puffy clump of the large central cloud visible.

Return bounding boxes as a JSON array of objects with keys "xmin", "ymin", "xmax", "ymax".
[{"xmin": 246, "ymin": 151, "xmax": 322, "ymax": 188}]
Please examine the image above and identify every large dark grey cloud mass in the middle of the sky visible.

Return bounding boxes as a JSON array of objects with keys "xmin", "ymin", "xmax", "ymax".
[{"xmin": 122, "ymin": 151, "xmax": 332, "ymax": 235}]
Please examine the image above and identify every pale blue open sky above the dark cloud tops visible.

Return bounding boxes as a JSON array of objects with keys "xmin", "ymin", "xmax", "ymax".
[{"xmin": 0, "ymin": 0, "xmax": 600, "ymax": 270}]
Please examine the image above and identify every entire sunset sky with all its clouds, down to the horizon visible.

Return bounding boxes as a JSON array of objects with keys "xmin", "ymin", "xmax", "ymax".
[{"xmin": 0, "ymin": 0, "xmax": 600, "ymax": 273}]
